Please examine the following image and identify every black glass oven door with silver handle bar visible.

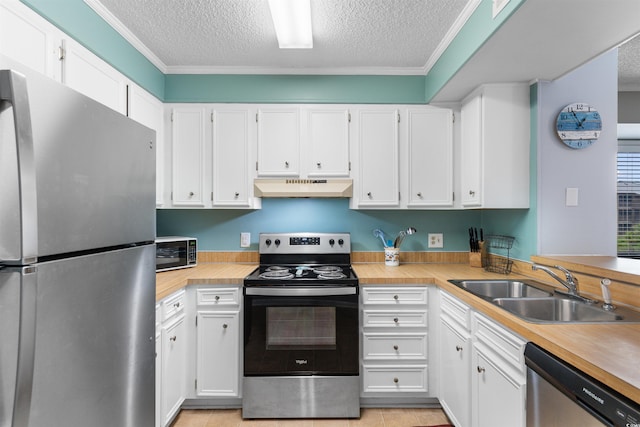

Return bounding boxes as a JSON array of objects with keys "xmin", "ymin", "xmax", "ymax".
[{"xmin": 244, "ymin": 286, "xmax": 359, "ymax": 377}]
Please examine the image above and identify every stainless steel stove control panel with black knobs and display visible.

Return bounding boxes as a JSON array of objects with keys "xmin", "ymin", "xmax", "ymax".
[{"xmin": 259, "ymin": 233, "xmax": 351, "ymax": 254}]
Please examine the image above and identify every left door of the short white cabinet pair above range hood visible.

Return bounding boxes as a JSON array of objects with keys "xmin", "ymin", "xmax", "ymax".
[{"xmin": 258, "ymin": 108, "xmax": 300, "ymax": 176}]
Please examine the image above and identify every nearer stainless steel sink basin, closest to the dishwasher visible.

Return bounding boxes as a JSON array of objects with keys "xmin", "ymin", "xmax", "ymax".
[{"xmin": 493, "ymin": 297, "xmax": 640, "ymax": 323}]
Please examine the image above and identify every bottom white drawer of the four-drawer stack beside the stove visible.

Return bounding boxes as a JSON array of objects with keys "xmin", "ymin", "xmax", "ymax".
[{"xmin": 363, "ymin": 365, "xmax": 427, "ymax": 393}]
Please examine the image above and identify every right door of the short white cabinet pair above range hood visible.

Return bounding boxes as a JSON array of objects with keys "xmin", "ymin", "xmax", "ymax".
[{"xmin": 307, "ymin": 108, "xmax": 349, "ymax": 177}]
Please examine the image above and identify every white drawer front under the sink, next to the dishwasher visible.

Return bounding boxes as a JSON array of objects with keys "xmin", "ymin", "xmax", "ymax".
[{"xmin": 474, "ymin": 313, "xmax": 526, "ymax": 372}]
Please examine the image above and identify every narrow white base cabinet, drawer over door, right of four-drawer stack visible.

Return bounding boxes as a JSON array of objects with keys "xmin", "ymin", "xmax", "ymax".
[{"xmin": 438, "ymin": 292, "xmax": 472, "ymax": 427}]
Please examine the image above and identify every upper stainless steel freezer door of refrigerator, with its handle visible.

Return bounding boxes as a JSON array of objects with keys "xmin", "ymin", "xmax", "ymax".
[{"xmin": 0, "ymin": 57, "xmax": 155, "ymax": 264}]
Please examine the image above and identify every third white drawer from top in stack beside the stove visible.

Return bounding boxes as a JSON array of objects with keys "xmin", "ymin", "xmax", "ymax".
[{"xmin": 362, "ymin": 333, "xmax": 427, "ymax": 361}]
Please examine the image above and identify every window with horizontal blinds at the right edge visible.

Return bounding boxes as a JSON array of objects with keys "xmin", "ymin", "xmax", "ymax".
[{"xmin": 617, "ymin": 140, "xmax": 640, "ymax": 258}]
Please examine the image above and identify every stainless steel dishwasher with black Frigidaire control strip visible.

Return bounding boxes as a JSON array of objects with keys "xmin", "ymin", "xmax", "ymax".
[{"xmin": 524, "ymin": 343, "xmax": 640, "ymax": 427}]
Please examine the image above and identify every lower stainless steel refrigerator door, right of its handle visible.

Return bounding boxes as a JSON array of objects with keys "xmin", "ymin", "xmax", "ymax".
[{"xmin": 28, "ymin": 245, "xmax": 155, "ymax": 427}]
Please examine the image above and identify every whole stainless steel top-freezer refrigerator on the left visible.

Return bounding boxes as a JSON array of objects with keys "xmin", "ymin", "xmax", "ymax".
[{"xmin": 0, "ymin": 56, "xmax": 155, "ymax": 427}]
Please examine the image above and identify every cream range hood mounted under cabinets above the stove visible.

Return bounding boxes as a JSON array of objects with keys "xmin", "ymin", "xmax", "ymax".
[{"xmin": 253, "ymin": 179, "xmax": 353, "ymax": 197}]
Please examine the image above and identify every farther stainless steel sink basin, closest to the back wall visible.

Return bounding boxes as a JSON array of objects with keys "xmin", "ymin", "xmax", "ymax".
[{"xmin": 449, "ymin": 280, "xmax": 553, "ymax": 300}]
